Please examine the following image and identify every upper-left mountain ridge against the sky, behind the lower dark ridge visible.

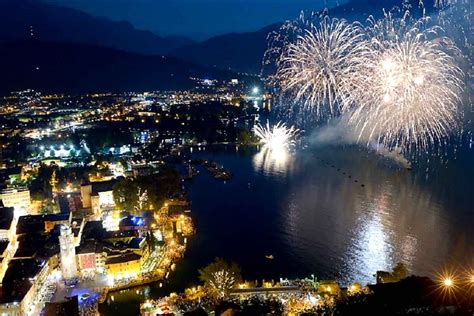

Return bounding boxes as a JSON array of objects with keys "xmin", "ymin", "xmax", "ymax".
[{"xmin": 0, "ymin": 0, "xmax": 192, "ymax": 55}]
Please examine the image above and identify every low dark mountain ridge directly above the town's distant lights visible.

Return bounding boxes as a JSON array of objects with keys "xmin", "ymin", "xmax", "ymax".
[{"xmin": 0, "ymin": 41, "xmax": 250, "ymax": 94}]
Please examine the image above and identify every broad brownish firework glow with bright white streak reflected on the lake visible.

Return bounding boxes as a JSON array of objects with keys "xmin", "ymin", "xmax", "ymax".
[{"xmin": 282, "ymin": 149, "xmax": 456, "ymax": 284}]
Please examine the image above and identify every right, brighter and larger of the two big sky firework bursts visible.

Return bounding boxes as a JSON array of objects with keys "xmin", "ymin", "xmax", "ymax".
[{"xmin": 343, "ymin": 15, "xmax": 462, "ymax": 149}]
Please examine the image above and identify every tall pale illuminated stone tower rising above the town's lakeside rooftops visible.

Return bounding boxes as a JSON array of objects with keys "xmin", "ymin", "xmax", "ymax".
[{"xmin": 59, "ymin": 225, "xmax": 77, "ymax": 281}]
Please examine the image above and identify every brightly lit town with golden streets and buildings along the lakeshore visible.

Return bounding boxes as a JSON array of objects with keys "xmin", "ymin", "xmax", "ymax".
[{"xmin": 0, "ymin": 79, "xmax": 271, "ymax": 315}]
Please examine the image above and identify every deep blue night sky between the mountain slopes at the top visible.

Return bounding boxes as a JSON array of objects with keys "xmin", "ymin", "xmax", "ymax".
[{"xmin": 45, "ymin": 0, "xmax": 346, "ymax": 39}]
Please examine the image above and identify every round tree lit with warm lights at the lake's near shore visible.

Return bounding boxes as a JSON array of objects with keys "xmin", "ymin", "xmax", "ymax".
[{"xmin": 199, "ymin": 258, "xmax": 242, "ymax": 298}]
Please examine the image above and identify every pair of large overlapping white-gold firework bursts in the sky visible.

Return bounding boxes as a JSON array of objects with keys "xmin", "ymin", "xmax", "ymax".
[{"xmin": 262, "ymin": 5, "xmax": 463, "ymax": 153}]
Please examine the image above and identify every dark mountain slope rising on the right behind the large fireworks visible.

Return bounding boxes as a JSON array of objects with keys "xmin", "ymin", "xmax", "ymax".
[{"xmin": 170, "ymin": 0, "xmax": 434, "ymax": 74}]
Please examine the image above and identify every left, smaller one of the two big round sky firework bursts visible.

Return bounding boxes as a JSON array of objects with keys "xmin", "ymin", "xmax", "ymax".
[{"xmin": 276, "ymin": 17, "xmax": 368, "ymax": 117}]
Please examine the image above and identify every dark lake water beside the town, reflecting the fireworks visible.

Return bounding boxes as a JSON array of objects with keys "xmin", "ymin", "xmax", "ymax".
[{"xmin": 103, "ymin": 146, "xmax": 474, "ymax": 316}]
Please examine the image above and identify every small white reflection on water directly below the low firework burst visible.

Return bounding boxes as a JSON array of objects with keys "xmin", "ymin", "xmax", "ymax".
[{"xmin": 253, "ymin": 146, "xmax": 294, "ymax": 175}]
